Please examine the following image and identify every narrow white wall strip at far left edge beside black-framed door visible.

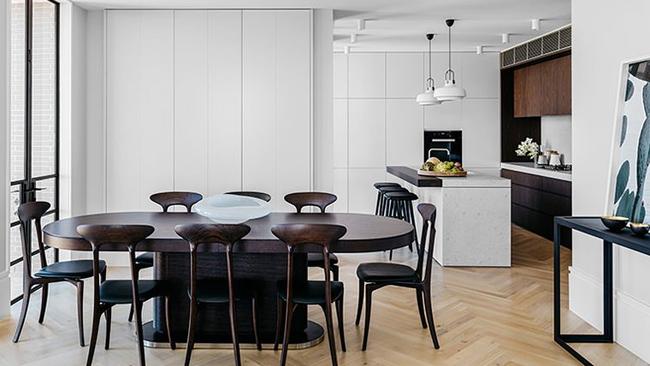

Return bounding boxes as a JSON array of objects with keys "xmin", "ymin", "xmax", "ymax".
[{"xmin": 0, "ymin": 1, "xmax": 11, "ymax": 319}]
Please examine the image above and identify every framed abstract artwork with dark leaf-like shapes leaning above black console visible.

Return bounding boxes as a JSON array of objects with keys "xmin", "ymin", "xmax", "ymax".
[{"xmin": 607, "ymin": 57, "xmax": 650, "ymax": 222}]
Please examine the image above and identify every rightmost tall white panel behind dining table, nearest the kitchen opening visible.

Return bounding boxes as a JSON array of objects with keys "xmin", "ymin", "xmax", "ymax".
[{"xmin": 242, "ymin": 11, "xmax": 311, "ymax": 210}]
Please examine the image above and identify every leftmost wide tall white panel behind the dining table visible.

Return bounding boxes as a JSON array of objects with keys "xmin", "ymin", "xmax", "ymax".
[{"xmin": 105, "ymin": 10, "xmax": 173, "ymax": 211}]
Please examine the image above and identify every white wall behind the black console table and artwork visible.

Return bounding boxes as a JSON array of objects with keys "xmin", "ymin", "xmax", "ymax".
[{"xmin": 569, "ymin": 0, "xmax": 650, "ymax": 362}]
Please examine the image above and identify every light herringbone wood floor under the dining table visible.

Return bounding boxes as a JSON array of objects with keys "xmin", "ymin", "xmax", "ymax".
[{"xmin": 0, "ymin": 227, "xmax": 644, "ymax": 366}]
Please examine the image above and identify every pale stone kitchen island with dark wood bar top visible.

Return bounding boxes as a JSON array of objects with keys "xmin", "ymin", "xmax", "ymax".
[{"xmin": 386, "ymin": 166, "xmax": 510, "ymax": 267}]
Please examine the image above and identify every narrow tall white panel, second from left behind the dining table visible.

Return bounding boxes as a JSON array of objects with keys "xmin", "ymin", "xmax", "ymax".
[{"xmin": 174, "ymin": 10, "xmax": 208, "ymax": 195}]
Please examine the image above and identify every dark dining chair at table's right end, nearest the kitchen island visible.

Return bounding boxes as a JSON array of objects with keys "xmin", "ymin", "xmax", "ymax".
[{"xmin": 354, "ymin": 203, "xmax": 440, "ymax": 351}]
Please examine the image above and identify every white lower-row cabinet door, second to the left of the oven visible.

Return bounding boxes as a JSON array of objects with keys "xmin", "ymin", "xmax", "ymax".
[{"xmin": 348, "ymin": 99, "xmax": 386, "ymax": 168}]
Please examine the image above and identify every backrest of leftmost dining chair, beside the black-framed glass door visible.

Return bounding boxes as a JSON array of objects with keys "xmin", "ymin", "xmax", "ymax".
[{"xmin": 18, "ymin": 201, "xmax": 50, "ymax": 278}]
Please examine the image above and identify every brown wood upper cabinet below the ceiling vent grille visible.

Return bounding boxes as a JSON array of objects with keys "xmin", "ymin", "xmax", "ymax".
[{"xmin": 514, "ymin": 55, "xmax": 571, "ymax": 117}]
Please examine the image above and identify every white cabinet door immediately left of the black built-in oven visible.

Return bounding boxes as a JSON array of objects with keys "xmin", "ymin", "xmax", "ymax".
[{"xmin": 386, "ymin": 99, "xmax": 425, "ymax": 166}]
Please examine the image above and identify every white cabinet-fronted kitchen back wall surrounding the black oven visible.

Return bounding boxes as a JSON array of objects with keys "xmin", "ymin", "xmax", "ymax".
[{"xmin": 333, "ymin": 52, "xmax": 501, "ymax": 213}]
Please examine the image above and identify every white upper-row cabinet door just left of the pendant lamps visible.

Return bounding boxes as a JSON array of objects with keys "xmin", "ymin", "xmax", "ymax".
[{"xmin": 386, "ymin": 53, "xmax": 428, "ymax": 98}]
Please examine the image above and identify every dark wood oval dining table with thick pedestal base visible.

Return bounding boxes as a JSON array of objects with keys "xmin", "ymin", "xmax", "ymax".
[{"xmin": 43, "ymin": 212, "xmax": 415, "ymax": 348}]
